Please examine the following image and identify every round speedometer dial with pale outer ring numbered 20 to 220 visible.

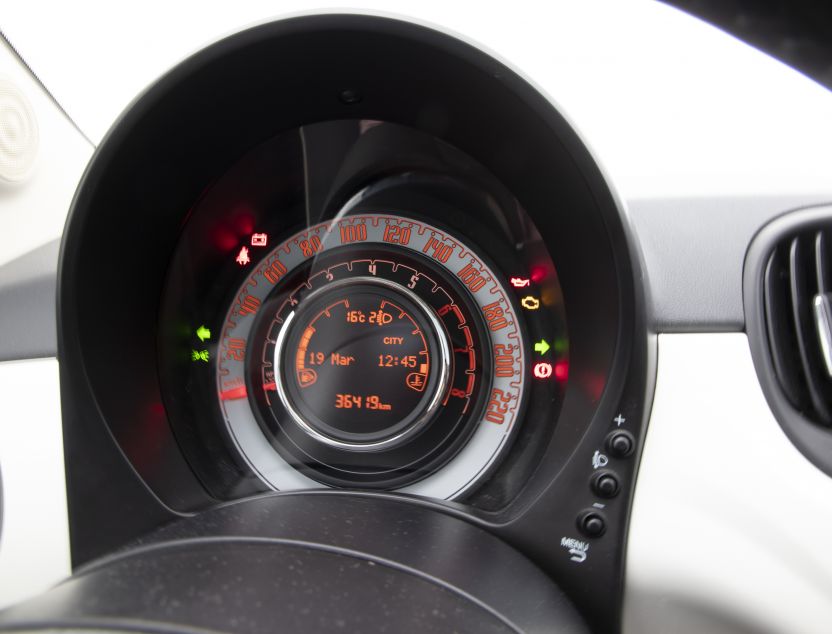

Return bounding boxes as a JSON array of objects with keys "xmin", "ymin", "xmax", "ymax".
[{"xmin": 217, "ymin": 212, "xmax": 526, "ymax": 498}]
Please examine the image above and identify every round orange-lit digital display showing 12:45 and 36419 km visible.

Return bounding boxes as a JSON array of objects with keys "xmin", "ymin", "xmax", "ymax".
[{"xmin": 282, "ymin": 283, "xmax": 435, "ymax": 442}]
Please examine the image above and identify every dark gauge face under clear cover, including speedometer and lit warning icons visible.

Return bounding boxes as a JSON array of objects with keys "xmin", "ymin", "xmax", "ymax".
[{"xmin": 159, "ymin": 120, "xmax": 568, "ymax": 508}]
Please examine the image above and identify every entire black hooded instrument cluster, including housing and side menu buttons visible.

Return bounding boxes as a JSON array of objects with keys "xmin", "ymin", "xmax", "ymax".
[{"xmin": 58, "ymin": 15, "xmax": 655, "ymax": 631}]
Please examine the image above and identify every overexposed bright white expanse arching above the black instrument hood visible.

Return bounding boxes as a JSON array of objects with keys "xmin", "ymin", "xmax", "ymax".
[{"xmin": 0, "ymin": 0, "xmax": 832, "ymax": 198}]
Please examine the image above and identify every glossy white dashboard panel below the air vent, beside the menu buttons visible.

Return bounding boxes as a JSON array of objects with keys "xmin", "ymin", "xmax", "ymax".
[{"xmin": 624, "ymin": 334, "xmax": 832, "ymax": 634}]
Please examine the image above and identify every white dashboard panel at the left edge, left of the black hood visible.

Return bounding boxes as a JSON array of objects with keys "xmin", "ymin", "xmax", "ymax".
[{"xmin": 0, "ymin": 359, "xmax": 70, "ymax": 608}]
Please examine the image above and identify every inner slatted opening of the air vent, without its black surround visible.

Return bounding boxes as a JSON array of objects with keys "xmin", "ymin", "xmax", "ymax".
[{"xmin": 763, "ymin": 230, "xmax": 832, "ymax": 425}]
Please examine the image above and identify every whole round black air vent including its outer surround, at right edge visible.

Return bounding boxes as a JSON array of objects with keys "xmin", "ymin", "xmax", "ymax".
[{"xmin": 743, "ymin": 207, "xmax": 832, "ymax": 475}]
